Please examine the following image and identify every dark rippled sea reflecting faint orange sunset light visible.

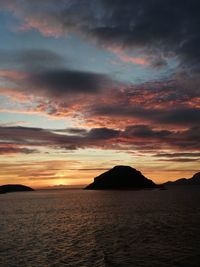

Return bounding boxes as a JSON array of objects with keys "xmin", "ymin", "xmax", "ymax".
[{"xmin": 0, "ymin": 187, "xmax": 200, "ymax": 267}]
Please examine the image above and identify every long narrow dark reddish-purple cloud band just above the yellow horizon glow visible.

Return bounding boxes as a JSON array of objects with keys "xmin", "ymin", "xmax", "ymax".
[{"xmin": 0, "ymin": 125, "xmax": 200, "ymax": 153}]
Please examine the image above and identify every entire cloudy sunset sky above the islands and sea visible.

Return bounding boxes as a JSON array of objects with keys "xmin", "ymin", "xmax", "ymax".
[{"xmin": 0, "ymin": 0, "xmax": 200, "ymax": 188}]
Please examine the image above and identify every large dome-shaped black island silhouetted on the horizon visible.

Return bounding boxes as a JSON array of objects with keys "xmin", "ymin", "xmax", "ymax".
[{"xmin": 85, "ymin": 166, "xmax": 159, "ymax": 190}]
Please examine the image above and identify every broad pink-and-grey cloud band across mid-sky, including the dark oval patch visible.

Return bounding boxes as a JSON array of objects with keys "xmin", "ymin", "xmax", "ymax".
[{"xmin": 0, "ymin": 62, "xmax": 200, "ymax": 130}]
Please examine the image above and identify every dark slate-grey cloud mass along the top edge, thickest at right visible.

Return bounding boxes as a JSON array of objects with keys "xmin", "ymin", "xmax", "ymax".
[{"xmin": 0, "ymin": 0, "xmax": 200, "ymax": 69}]
